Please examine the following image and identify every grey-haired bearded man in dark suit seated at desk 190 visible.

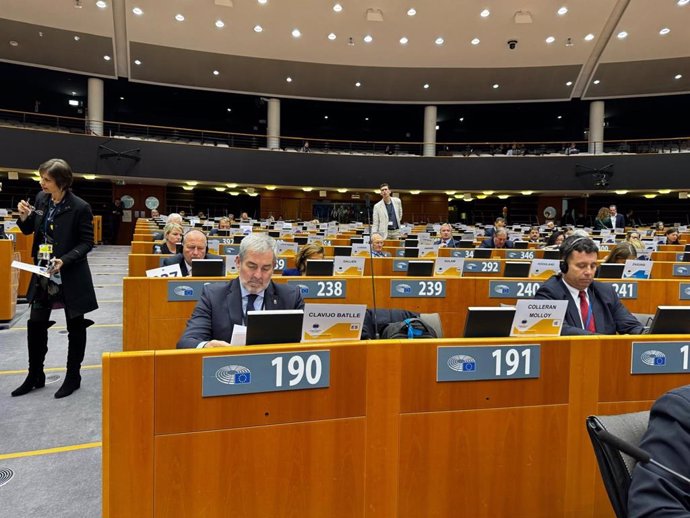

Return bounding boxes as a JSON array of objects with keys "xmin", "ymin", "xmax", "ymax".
[{"xmin": 177, "ymin": 234, "xmax": 304, "ymax": 349}]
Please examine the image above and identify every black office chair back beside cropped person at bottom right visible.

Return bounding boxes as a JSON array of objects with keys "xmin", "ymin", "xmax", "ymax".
[{"xmin": 587, "ymin": 411, "xmax": 649, "ymax": 518}]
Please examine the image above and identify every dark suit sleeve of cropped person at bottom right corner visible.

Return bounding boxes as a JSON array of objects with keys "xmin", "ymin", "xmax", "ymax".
[{"xmin": 628, "ymin": 392, "xmax": 690, "ymax": 518}]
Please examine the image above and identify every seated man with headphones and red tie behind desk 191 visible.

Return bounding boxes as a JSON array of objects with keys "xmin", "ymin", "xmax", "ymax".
[{"xmin": 534, "ymin": 236, "xmax": 644, "ymax": 335}]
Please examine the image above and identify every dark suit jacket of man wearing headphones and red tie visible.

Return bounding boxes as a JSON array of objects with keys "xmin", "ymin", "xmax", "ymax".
[{"xmin": 534, "ymin": 275, "xmax": 644, "ymax": 335}]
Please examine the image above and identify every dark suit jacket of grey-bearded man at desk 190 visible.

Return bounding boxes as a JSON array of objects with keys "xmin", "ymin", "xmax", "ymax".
[{"xmin": 177, "ymin": 279, "xmax": 304, "ymax": 349}]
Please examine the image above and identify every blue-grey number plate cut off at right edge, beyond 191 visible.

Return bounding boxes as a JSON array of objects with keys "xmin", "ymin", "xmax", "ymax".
[{"xmin": 630, "ymin": 341, "xmax": 690, "ymax": 374}]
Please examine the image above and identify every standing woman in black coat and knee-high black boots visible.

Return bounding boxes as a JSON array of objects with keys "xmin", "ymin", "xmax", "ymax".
[{"xmin": 12, "ymin": 158, "xmax": 98, "ymax": 398}]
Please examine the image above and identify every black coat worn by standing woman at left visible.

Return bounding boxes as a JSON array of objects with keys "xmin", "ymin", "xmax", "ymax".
[{"xmin": 17, "ymin": 191, "xmax": 98, "ymax": 314}]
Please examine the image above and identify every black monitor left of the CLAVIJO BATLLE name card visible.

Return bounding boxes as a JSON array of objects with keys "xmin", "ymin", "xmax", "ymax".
[{"xmin": 246, "ymin": 309, "xmax": 304, "ymax": 345}]
